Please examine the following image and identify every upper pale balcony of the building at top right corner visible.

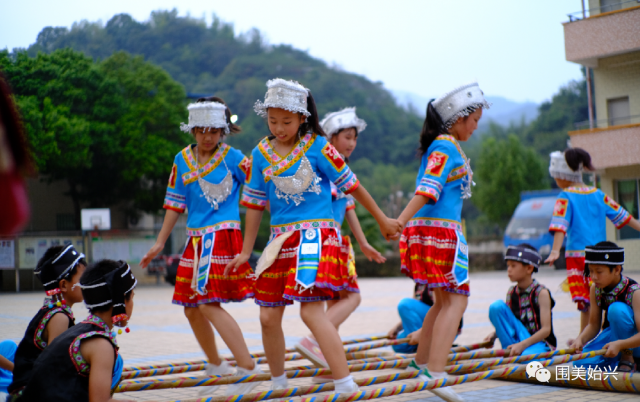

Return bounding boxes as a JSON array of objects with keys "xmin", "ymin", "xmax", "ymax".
[{"xmin": 563, "ymin": 0, "xmax": 640, "ymax": 68}]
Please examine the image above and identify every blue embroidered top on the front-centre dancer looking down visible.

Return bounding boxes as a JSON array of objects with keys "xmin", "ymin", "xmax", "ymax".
[{"xmin": 240, "ymin": 133, "xmax": 360, "ymax": 234}]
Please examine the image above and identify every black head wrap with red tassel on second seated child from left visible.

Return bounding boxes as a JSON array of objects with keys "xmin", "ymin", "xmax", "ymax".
[{"xmin": 80, "ymin": 261, "xmax": 138, "ymax": 326}]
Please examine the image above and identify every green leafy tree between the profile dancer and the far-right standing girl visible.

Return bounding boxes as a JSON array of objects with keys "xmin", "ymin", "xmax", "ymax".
[{"xmin": 472, "ymin": 135, "xmax": 548, "ymax": 227}]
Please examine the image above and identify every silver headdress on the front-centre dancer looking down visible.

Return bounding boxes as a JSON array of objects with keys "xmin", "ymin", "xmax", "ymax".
[{"xmin": 253, "ymin": 78, "xmax": 311, "ymax": 118}]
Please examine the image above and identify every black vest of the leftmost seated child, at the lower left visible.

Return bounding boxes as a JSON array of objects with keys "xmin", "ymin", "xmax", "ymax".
[{"xmin": 8, "ymin": 301, "xmax": 74, "ymax": 393}]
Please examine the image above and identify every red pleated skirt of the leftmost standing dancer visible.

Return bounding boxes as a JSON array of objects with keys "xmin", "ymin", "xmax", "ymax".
[{"xmin": 173, "ymin": 229, "xmax": 254, "ymax": 307}]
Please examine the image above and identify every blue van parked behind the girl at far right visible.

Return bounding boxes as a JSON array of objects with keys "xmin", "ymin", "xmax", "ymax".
[{"xmin": 504, "ymin": 189, "xmax": 567, "ymax": 269}]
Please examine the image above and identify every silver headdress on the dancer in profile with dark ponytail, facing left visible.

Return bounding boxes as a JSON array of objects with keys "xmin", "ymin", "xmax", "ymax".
[{"xmin": 433, "ymin": 82, "xmax": 491, "ymax": 130}]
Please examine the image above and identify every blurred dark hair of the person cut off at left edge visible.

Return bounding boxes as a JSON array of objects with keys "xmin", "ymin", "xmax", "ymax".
[{"xmin": 0, "ymin": 71, "xmax": 35, "ymax": 176}]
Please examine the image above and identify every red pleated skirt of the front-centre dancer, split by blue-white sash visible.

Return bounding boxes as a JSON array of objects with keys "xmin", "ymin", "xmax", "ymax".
[{"xmin": 254, "ymin": 229, "xmax": 349, "ymax": 307}]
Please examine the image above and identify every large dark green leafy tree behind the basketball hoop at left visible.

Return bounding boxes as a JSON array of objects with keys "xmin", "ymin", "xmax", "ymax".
[{"xmin": 0, "ymin": 49, "xmax": 188, "ymax": 227}]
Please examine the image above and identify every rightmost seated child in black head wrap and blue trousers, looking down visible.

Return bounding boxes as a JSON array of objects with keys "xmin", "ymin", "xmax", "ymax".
[{"xmin": 570, "ymin": 241, "xmax": 640, "ymax": 372}]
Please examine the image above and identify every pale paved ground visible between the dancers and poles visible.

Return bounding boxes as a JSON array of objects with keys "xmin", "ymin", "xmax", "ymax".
[{"xmin": 0, "ymin": 268, "xmax": 640, "ymax": 402}]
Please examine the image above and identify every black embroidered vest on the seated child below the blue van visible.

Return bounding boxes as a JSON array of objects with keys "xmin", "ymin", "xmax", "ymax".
[{"xmin": 507, "ymin": 279, "xmax": 558, "ymax": 348}]
